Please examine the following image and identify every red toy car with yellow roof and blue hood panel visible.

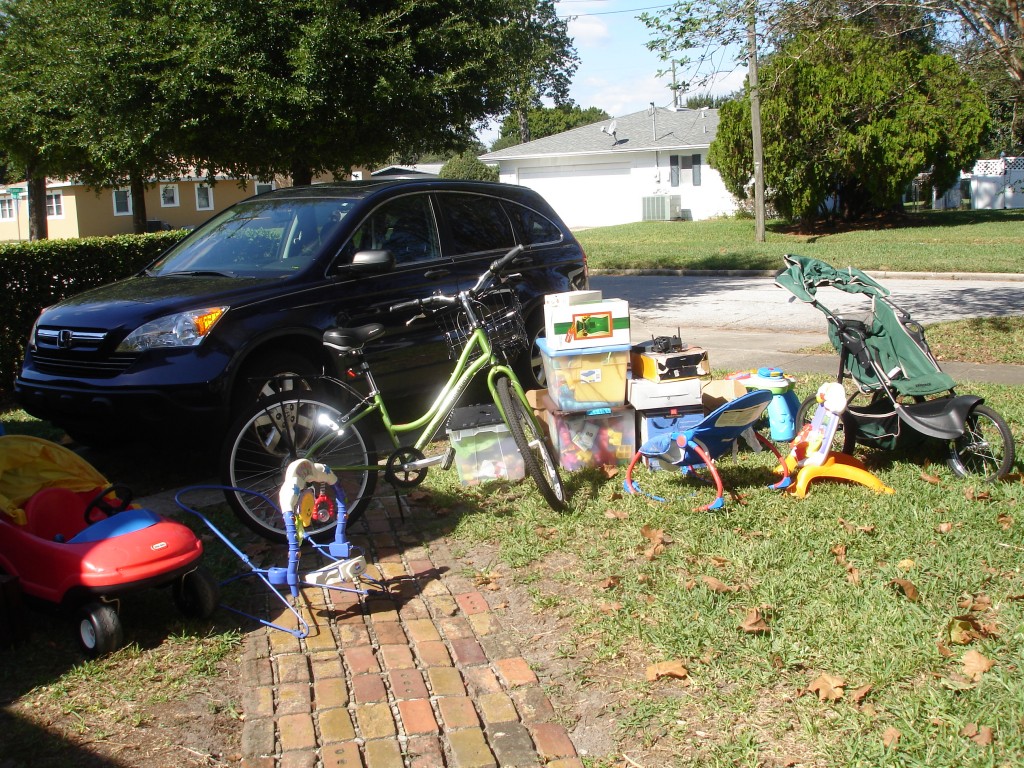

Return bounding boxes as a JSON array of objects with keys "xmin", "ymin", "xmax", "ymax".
[{"xmin": 0, "ymin": 435, "xmax": 219, "ymax": 655}]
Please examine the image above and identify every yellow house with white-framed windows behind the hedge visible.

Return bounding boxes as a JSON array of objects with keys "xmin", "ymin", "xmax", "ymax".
[{"xmin": 0, "ymin": 176, "xmax": 281, "ymax": 243}]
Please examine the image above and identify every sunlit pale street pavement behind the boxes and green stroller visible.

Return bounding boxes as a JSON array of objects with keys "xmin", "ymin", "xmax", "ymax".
[{"xmin": 590, "ymin": 272, "xmax": 1024, "ymax": 385}]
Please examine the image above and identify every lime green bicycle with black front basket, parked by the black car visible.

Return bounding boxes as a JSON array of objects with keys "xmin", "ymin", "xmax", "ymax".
[{"xmin": 220, "ymin": 246, "xmax": 566, "ymax": 541}]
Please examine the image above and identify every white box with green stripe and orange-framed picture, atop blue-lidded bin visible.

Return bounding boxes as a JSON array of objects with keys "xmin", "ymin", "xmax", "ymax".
[{"xmin": 544, "ymin": 291, "xmax": 630, "ymax": 351}]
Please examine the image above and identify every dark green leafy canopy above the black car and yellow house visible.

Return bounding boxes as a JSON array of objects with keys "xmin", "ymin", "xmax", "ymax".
[{"xmin": 0, "ymin": 0, "xmax": 575, "ymax": 234}]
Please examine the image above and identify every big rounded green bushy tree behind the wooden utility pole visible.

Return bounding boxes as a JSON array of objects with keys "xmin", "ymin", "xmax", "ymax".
[{"xmin": 709, "ymin": 26, "xmax": 988, "ymax": 220}]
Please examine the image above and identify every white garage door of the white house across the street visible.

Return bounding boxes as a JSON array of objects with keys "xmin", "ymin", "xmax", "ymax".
[{"xmin": 519, "ymin": 164, "xmax": 640, "ymax": 227}]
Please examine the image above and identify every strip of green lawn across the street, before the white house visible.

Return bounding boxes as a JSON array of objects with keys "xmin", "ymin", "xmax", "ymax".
[{"xmin": 577, "ymin": 211, "xmax": 1024, "ymax": 272}]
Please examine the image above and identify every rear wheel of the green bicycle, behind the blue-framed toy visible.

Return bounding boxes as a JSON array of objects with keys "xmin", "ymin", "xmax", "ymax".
[{"xmin": 220, "ymin": 391, "xmax": 377, "ymax": 542}]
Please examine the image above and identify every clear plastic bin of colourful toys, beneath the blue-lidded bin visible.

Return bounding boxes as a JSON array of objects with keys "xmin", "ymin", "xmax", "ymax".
[{"xmin": 547, "ymin": 406, "xmax": 636, "ymax": 471}]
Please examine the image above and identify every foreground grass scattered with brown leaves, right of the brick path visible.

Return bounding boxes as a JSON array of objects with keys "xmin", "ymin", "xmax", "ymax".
[{"xmin": 417, "ymin": 370, "xmax": 1024, "ymax": 768}]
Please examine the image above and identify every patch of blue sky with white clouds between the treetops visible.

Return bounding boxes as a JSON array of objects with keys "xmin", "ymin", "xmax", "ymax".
[{"xmin": 481, "ymin": 0, "xmax": 746, "ymax": 143}]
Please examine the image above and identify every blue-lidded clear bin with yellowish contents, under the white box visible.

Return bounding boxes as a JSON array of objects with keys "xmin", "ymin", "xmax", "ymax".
[{"xmin": 537, "ymin": 339, "xmax": 630, "ymax": 411}]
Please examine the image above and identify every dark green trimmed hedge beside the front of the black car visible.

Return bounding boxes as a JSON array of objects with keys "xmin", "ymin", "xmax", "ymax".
[{"xmin": 0, "ymin": 229, "xmax": 187, "ymax": 403}]
